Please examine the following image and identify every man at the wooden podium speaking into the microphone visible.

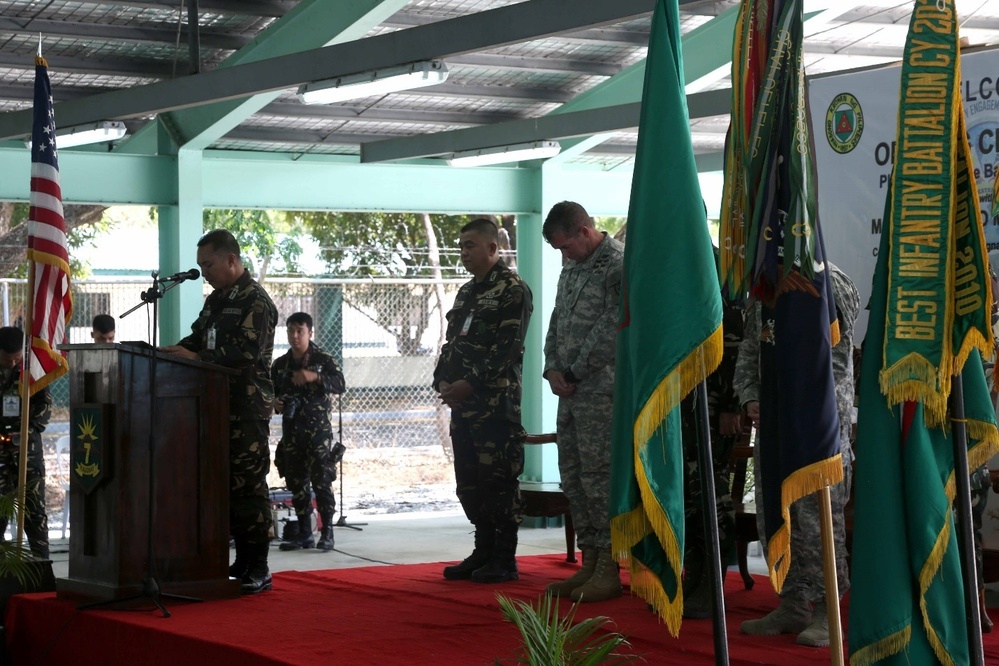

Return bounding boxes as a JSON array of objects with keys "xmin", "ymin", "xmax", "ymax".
[{"xmin": 164, "ymin": 229, "xmax": 277, "ymax": 594}]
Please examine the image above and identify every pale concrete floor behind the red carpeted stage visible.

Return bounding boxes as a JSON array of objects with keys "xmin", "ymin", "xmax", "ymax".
[{"xmin": 45, "ymin": 511, "xmax": 766, "ymax": 578}]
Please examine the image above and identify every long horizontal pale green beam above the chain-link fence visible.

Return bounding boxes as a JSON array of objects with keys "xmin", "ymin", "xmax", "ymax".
[{"xmin": 0, "ymin": 146, "xmax": 584, "ymax": 213}]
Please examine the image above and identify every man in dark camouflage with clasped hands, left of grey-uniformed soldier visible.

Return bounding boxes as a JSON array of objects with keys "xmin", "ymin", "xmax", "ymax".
[{"xmin": 433, "ymin": 218, "xmax": 533, "ymax": 583}]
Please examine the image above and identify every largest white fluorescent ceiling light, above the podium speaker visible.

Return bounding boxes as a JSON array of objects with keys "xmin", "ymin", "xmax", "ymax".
[{"xmin": 298, "ymin": 60, "xmax": 448, "ymax": 104}]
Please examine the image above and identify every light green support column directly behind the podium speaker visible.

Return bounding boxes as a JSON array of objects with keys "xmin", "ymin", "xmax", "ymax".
[{"xmin": 158, "ymin": 148, "xmax": 204, "ymax": 344}]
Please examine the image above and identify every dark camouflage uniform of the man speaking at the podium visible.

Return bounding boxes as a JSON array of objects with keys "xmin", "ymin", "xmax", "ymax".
[{"xmin": 177, "ymin": 271, "xmax": 277, "ymax": 556}]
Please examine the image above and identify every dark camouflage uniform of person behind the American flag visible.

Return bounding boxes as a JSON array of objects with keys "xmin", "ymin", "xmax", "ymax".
[{"xmin": 0, "ymin": 367, "xmax": 52, "ymax": 559}]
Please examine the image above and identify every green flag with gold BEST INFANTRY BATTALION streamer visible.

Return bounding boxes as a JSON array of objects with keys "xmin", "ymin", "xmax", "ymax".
[{"xmin": 849, "ymin": 0, "xmax": 999, "ymax": 666}]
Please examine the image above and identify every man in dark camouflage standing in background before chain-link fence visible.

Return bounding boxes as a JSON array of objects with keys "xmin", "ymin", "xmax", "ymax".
[{"xmin": 271, "ymin": 312, "xmax": 344, "ymax": 551}]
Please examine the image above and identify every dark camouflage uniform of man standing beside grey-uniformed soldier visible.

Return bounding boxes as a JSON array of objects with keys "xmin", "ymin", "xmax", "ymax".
[{"xmin": 433, "ymin": 260, "xmax": 533, "ymax": 557}]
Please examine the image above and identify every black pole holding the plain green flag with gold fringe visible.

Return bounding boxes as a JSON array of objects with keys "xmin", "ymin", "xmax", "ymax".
[{"xmin": 695, "ymin": 379, "xmax": 728, "ymax": 666}]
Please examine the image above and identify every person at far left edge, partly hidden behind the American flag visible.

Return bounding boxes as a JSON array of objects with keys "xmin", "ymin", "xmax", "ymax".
[{"xmin": 0, "ymin": 326, "xmax": 52, "ymax": 559}]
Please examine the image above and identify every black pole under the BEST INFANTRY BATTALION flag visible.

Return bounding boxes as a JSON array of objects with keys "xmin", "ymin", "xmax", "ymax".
[{"xmin": 950, "ymin": 373, "xmax": 985, "ymax": 666}]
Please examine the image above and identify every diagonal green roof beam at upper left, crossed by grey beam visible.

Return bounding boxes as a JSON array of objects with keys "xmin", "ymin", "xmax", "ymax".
[{"xmin": 127, "ymin": 0, "xmax": 408, "ymax": 151}]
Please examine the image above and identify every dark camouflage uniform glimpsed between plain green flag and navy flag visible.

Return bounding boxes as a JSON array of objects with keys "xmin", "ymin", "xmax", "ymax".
[{"xmin": 680, "ymin": 298, "xmax": 744, "ymax": 596}]
